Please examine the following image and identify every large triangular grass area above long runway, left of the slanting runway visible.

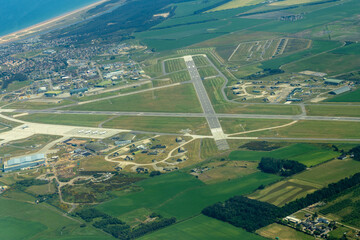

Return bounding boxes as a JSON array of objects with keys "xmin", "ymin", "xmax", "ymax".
[{"xmin": 67, "ymin": 84, "xmax": 202, "ymax": 112}]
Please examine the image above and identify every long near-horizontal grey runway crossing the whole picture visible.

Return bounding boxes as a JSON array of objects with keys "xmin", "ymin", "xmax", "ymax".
[{"xmin": 13, "ymin": 109, "xmax": 360, "ymax": 122}]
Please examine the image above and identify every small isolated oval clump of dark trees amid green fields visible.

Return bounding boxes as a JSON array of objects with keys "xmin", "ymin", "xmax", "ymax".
[{"xmin": 259, "ymin": 157, "xmax": 306, "ymax": 177}]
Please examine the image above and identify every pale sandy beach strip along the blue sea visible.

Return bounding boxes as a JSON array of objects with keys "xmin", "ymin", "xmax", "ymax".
[{"xmin": 0, "ymin": 0, "xmax": 109, "ymax": 44}]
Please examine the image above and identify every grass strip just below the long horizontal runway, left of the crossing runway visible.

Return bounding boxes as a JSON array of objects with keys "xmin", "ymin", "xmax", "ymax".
[{"xmin": 103, "ymin": 116, "xmax": 210, "ymax": 135}]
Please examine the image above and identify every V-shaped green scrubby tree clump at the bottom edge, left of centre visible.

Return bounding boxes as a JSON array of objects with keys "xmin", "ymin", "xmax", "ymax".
[{"xmin": 76, "ymin": 208, "xmax": 176, "ymax": 240}]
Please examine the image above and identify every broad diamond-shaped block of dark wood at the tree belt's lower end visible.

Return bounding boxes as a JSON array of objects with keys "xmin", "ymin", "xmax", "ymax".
[{"xmin": 202, "ymin": 196, "xmax": 283, "ymax": 232}]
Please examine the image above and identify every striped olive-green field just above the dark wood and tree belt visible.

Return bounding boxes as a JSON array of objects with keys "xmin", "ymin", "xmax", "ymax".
[{"xmin": 249, "ymin": 179, "xmax": 322, "ymax": 206}]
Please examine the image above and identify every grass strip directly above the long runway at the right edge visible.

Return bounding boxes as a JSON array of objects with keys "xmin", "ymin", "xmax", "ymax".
[{"xmin": 306, "ymin": 105, "xmax": 360, "ymax": 117}]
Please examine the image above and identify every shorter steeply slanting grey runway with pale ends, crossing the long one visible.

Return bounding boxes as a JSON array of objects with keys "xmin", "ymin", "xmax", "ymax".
[{"xmin": 184, "ymin": 56, "xmax": 230, "ymax": 150}]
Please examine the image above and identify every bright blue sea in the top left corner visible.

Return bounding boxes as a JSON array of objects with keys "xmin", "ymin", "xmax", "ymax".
[{"xmin": 0, "ymin": 0, "xmax": 100, "ymax": 36}]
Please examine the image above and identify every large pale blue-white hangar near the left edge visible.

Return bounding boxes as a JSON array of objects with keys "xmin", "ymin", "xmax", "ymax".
[{"xmin": 3, "ymin": 154, "xmax": 45, "ymax": 172}]
